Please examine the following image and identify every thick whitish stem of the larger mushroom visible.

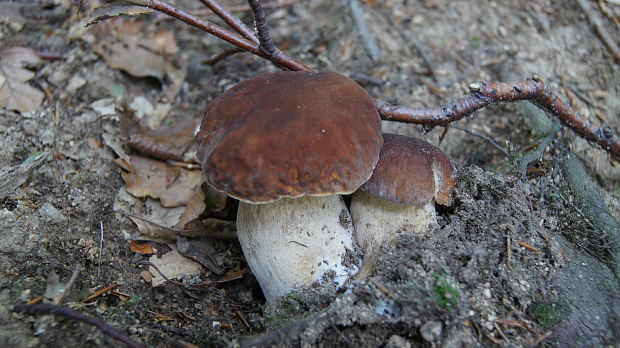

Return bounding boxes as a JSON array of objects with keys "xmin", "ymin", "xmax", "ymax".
[{"xmin": 237, "ymin": 195, "xmax": 360, "ymax": 302}]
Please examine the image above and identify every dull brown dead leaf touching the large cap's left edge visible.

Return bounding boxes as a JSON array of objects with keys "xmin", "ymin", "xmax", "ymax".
[{"xmin": 128, "ymin": 118, "xmax": 200, "ymax": 163}]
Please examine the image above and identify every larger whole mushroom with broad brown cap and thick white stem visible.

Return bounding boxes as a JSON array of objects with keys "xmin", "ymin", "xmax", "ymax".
[{"xmin": 197, "ymin": 72, "xmax": 382, "ymax": 302}]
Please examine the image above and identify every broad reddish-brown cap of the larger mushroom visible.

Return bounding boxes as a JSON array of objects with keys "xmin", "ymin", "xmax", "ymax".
[{"xmin": 197, "ymin": 72, "xmax": 382, "ymax": 203}]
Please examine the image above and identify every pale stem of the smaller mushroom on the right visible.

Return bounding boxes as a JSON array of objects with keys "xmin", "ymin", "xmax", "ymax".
[{"xmin": 351, "ymin": 191, "xmax": 437, "ymax": 255}]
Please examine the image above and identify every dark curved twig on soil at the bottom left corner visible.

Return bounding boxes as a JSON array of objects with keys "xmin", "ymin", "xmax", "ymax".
[{"xmin": 13, "ymin": 303, "xmax": 143, "ymax": 348}]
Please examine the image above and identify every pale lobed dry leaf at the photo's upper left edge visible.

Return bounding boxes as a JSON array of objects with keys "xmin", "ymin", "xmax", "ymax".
[{"xmin": 0, "ymin": 47, "xmax": 44, "ymax": 112}]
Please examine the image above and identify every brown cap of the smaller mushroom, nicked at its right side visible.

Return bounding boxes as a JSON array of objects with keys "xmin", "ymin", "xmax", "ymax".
[{"xmin": 360, "ymin": 134, "xmax": 456, "ymax": 207}]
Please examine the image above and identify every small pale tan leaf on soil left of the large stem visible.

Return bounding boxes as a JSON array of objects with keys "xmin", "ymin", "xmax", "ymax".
[{"xmin": 149, "ymin": 249, "xmax": 203, "ymax": 287}]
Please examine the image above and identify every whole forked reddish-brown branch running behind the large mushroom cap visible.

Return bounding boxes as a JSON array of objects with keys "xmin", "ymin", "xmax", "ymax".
[{"xmin": 115, "ymin": 0, "xmax": 620, "ymax": 156}]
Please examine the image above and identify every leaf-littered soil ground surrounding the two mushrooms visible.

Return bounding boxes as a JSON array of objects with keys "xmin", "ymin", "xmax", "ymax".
[{"xmin": 0, "ymin": 0, "xmax": 620, "ymax": 347}]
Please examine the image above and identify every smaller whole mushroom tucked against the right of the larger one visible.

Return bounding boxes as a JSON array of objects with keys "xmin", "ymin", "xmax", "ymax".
[{"xmin": 351, "ymin": 134, "xmax": 456, "ymax": 255}]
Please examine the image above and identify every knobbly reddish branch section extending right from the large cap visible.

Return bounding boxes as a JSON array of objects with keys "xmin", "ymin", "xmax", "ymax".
[{"xmin": 375, "ymin": 76, "xmax": 620, "ymax": 156}]
